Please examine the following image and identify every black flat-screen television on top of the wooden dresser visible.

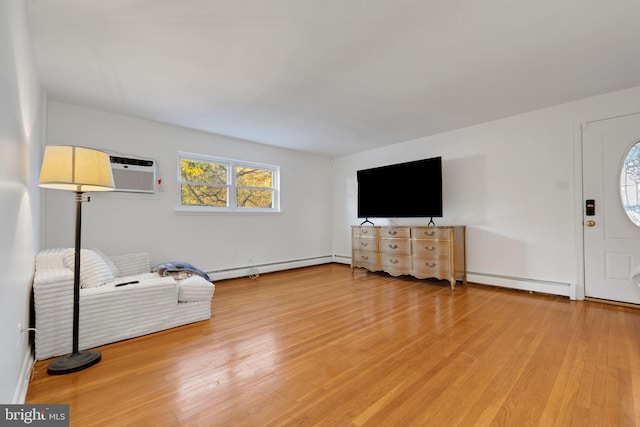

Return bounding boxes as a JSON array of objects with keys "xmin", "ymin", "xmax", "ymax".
[{"xmin": 357, "ymin": 157, "xmax": 442, "ymax": 218}]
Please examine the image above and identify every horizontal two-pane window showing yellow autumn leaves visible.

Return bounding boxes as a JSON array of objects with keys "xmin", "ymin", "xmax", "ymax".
[{"xmin": 178, "ymin": 152, "xmax": 280, "ymax": 212}]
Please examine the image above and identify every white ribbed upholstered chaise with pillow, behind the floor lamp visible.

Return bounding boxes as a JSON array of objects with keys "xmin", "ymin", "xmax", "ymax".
[{"xmin": 33, "ymin": 248, "xmax": 215, "ymax": 360}]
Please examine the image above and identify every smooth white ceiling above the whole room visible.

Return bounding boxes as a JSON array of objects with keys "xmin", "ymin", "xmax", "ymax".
[{"xmin": 27, "ymin": 0, "xmax": 640, "ymax": 157}]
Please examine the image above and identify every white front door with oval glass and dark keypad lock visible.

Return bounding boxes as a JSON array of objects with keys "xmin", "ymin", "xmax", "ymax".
[{"xmin": 582, "ymin": 114, "xmax": 640, "ymax": 304}]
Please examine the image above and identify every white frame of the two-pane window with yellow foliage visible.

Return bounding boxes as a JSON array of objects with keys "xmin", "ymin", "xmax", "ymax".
[{"xmin": 176, "ymin": 151, "xmax": 280, "ymax": 213}]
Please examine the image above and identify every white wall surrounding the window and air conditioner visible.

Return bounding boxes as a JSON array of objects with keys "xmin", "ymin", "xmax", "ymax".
[{"xmin": 45, "ymin": 102, "xmax": 332, "ymax": 278}]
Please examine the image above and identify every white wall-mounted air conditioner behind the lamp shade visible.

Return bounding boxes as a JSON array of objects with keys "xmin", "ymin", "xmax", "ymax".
[{"xmin": 109, "ymin": 155, "xmax": 156, "ymax": 193}]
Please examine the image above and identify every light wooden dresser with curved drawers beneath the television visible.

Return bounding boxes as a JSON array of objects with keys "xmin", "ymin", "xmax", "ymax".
[{"xmin": 351, "ymin": 226, "xmax": 467, "ymax": 289}]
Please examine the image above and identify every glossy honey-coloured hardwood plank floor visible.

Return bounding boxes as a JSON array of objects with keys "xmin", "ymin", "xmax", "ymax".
[{"xmin": 27, "ymin": 264, "xmax": 640, "ymax": 427}]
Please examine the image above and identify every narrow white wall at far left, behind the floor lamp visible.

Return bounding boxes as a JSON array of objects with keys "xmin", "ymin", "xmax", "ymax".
[{"xmin": 0, "ymin": 0, "xmax": 42, "ymax": 403}]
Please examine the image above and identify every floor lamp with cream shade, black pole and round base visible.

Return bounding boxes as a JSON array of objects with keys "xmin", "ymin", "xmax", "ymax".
[{"xmin": 38, "ymin": 145, "xmax": 113, "ymax": 375}]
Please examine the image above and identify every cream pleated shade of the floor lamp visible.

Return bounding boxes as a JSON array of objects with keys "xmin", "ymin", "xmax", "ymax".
[{"xmin": 38, "ymin": 145, "xmax": 114, "ymax": 192}]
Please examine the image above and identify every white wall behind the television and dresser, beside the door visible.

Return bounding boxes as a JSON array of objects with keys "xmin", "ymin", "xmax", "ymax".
[{"xmin": 333, "ymin": 87, "xmax": 640, "ymax": 297}]
